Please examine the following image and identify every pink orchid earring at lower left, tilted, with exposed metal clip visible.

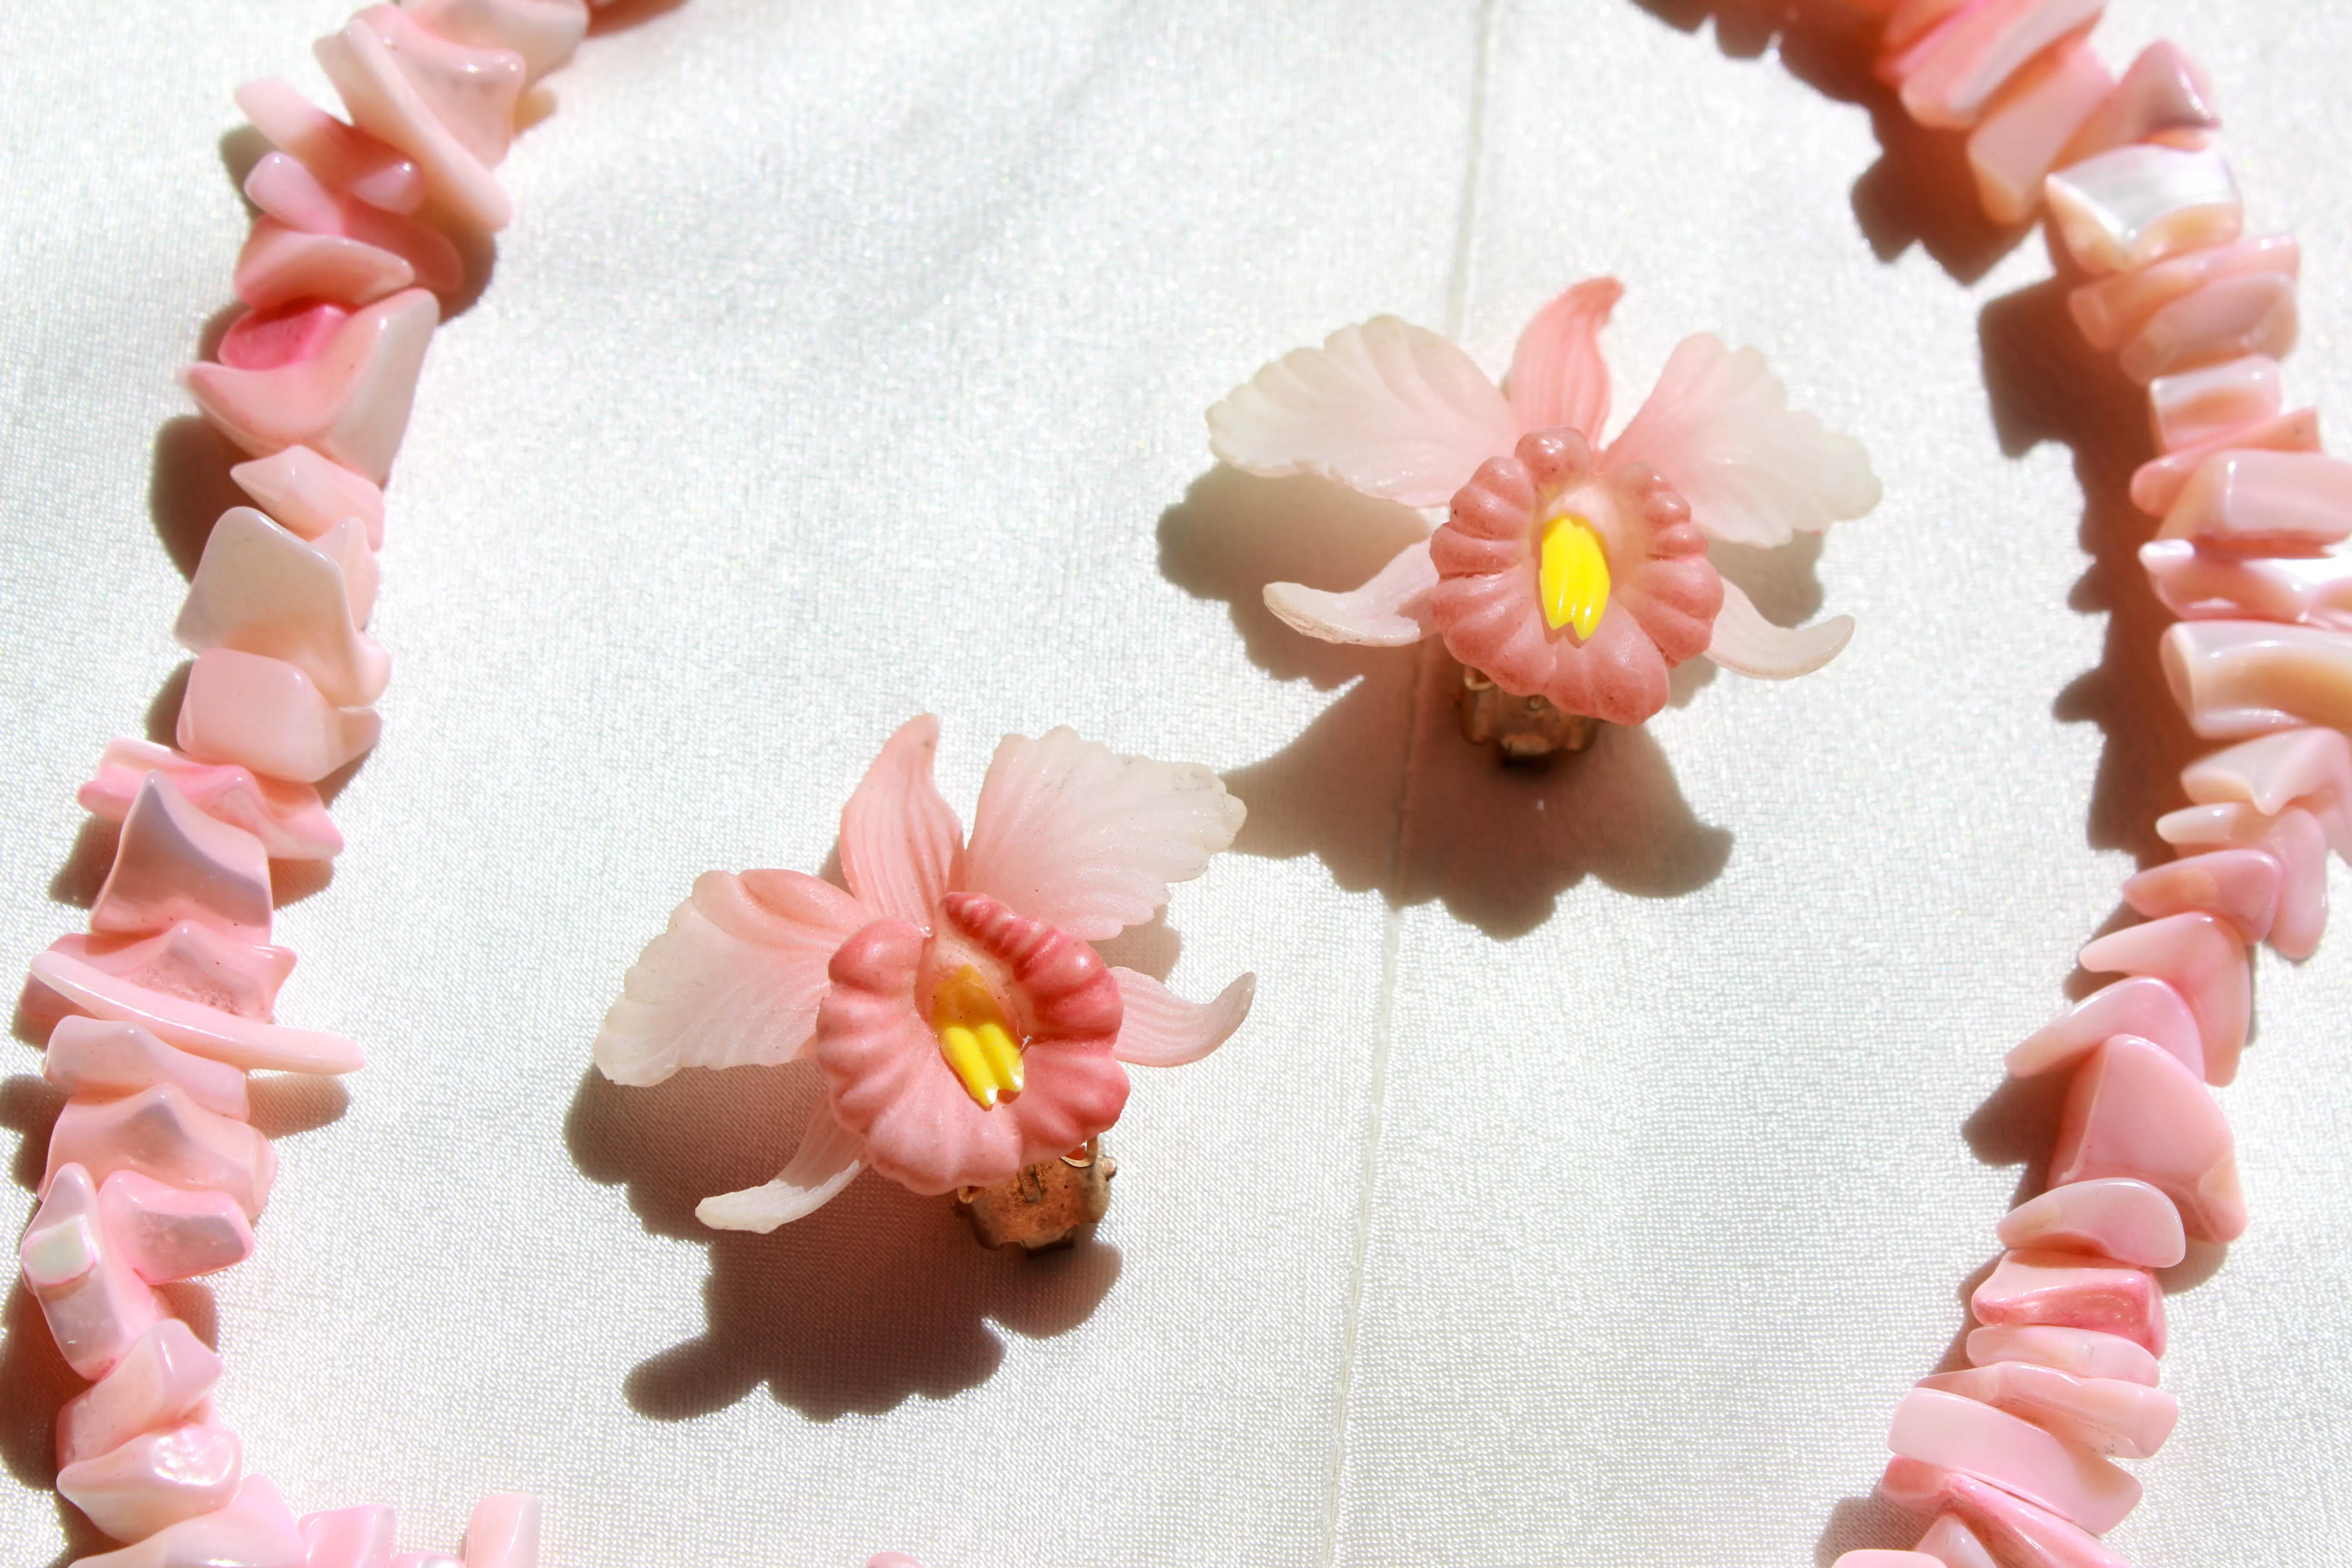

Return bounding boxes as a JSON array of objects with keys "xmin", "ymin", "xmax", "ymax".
[{"xmin": 595, "ymin": 715, "xmax": 1256, "ymax": 1251}]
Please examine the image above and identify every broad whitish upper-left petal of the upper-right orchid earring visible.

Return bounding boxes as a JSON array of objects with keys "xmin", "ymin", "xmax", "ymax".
[{"xmin": 1209, "ymin": 315, "xmax": 1519, "ymax": 505}]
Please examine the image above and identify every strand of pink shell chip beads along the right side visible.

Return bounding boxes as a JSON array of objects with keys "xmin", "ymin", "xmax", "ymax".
[{"xmin": 1839, "ymin": 0, "xmax": 2352, "ymax": 1568}]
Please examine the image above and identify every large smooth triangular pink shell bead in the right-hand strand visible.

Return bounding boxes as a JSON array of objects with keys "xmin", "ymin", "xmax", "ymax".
[{"xmin": 2051, "ymin": 1034, "xmax": 2246, "ymax": 1241}]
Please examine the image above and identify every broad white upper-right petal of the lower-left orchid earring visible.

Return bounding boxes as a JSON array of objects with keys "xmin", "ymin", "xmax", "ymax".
[{"xmin": 957, "ymin": 729, "xmax": 1247, "ymax": 943}]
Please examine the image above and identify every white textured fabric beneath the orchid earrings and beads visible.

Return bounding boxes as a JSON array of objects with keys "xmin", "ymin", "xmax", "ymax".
[{"xmin": 0, "ymin": 0, "xmax": 2352, "ymax": 1568}]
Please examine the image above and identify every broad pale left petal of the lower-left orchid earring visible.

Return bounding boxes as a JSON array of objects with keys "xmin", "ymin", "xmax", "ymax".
[{"xmin": 595, "ymin": 872, "xmax": 872, "ymax": 1084}]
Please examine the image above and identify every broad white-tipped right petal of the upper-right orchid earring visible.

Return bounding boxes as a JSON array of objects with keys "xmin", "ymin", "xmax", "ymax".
[{"xmin": 1607, "ymin": 332, "xmax": 1879, "ymax": 545}]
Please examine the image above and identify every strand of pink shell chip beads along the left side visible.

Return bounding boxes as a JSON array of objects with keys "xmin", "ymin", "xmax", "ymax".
[{"xmin": 19, "ymin": 0, "xmax": 621, "ymax": 1568}]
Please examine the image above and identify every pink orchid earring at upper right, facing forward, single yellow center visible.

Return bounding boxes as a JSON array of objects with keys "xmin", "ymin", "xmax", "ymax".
[{"xmin": 1209, "ymin": 277, "xmax": 1879, "ymax": 757}]
